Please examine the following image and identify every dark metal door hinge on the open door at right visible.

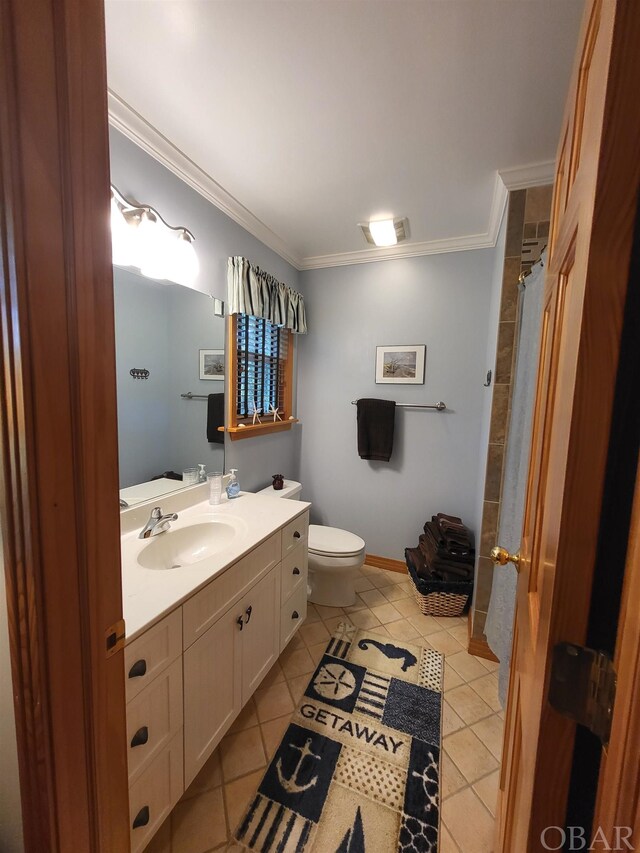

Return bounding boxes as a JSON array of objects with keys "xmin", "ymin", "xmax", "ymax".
[{"xmin": 549, "ymin": 643, "xmax": 616, "ymax": 746}]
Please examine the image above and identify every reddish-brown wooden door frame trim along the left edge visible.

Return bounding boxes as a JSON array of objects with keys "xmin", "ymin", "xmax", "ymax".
[{"xmin": 0, "ymin": 0, "xmax": 129, "ymax": 853}]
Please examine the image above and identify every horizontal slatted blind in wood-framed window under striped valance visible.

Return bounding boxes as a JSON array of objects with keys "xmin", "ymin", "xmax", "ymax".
[{"xmin": 236, "ymin": 314, "xmax": 288, "ymax": 418}]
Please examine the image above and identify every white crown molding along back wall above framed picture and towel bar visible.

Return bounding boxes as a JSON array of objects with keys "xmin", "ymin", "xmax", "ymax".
[{"xmin": 301, "ymin": 173, "xmax": 508, "ymax": 270}]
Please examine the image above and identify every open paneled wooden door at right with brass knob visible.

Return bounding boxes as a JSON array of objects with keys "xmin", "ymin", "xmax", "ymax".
[{"xmin": 496, "ymin": 0, "xmax": 640, "ymax": 853}]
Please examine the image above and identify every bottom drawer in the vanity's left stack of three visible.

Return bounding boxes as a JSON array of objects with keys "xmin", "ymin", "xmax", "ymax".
[{"xmin": 129, "ymin": 729, "xmax": 184, "ymax": 853}]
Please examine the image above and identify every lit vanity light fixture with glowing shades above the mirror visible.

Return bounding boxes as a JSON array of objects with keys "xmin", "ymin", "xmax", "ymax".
[{"xmin": 111, "ymin": 186, "xmax": 200, "ymax": 285}]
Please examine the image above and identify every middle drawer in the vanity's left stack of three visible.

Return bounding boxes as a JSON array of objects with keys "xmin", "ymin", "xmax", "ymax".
[{"xmin": 127, "ymin": 657, "xmax": 182, "ymax": 784}]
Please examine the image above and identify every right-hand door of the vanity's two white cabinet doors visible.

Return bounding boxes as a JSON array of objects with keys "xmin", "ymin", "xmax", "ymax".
[{"xmin": 240, "ymin": 566, "xmax": 280, "ymax": 705}]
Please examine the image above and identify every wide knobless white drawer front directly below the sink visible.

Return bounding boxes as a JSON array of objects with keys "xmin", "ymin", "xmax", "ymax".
[{"xmin": 182, "ymin": 532, "xmax": 280, "ymax": 649}]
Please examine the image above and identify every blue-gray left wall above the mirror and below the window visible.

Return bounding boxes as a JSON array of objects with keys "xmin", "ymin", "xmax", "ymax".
[{"xmin": 109, "ymin": 128, "xmax": 300, "ymax": 489}]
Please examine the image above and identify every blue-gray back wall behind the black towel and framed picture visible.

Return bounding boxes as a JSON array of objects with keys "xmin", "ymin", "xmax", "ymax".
[{"xmin": 298, "ymin": 249, "xmax": 495, "ymax": 559}]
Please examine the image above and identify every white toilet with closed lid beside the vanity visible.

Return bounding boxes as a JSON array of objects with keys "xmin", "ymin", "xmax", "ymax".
[{"xmin": 259, "ymin": 480, "xmax": 365, "ymax": 607}]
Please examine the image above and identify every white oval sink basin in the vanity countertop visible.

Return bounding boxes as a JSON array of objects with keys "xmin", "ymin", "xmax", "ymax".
[{"xmin": 138, "ymin": 521, "xmax": 238, "ymax": 569}]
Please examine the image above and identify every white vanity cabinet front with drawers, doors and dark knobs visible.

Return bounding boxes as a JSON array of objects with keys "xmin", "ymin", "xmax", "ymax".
[{"xmin": 125, "ymin": 512, "xmax": 309, "ymax": 853}]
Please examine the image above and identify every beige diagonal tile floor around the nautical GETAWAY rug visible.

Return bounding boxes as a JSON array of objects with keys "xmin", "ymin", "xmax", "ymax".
[{"xmin": 146, "ymin": 566, "xmax": 504, "ymax": 853}]
